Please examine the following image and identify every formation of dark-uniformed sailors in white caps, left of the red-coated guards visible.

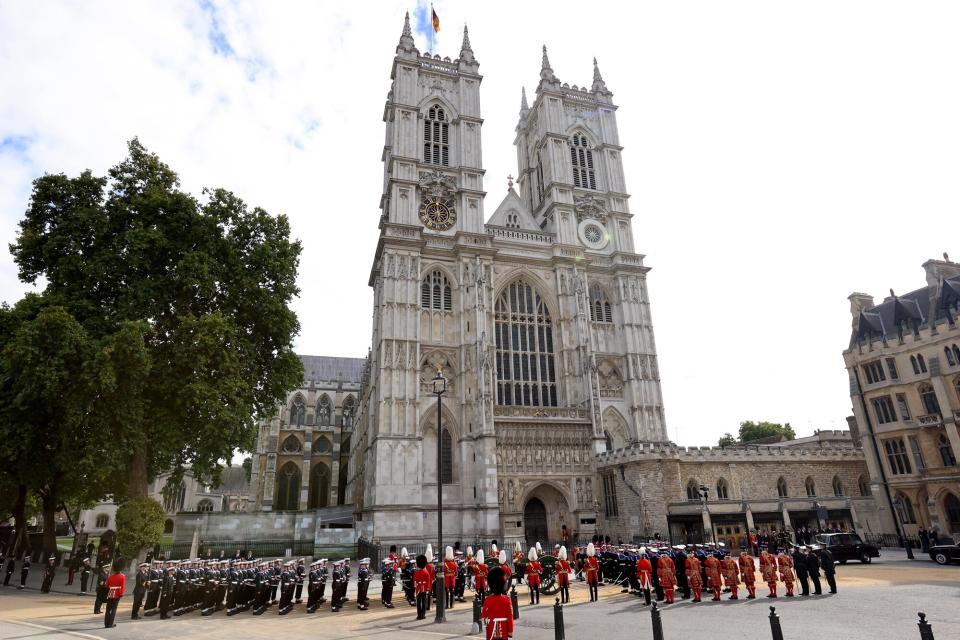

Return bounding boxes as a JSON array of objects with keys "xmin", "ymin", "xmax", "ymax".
[{"xmin": 132, "ymin": 558, "xmax": 370, "ymax": 619}]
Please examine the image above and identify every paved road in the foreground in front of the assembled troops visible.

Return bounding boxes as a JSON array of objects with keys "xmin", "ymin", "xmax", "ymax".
[{"xmin": 0, "ymin": 553, "xmax": 960, "ymax": 640}]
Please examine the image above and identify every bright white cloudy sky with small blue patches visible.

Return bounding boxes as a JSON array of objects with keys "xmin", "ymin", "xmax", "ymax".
[{"xmin": 0, "ymin": 0, "xmax": 960, "ymax": 445}]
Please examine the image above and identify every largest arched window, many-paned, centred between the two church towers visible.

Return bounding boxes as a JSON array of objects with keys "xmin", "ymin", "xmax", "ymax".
[{"xmin": 496, "ymin": 280, "xmax": 557, "ymax": 407}]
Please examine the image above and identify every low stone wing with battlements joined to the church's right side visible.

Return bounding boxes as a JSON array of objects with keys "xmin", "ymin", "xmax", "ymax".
[{"xmin": 597, "ymin": 432, "xmax": 890, "ymax": 547}]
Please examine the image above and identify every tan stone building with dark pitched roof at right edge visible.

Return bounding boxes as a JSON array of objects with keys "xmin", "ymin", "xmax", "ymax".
[{"xmin": 843, "ymin": 254, "xmax": 960, "ymax": 538}]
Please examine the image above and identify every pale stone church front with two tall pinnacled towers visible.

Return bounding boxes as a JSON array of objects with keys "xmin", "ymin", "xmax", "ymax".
[{"xmin": 347, "ymin": 16, "xmax": 667, "ymax": 545}]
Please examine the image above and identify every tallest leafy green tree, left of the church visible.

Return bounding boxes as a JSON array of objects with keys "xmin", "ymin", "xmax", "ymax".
[{"xmin": 11, "ymin": 139, "xmax": 303, "ymax": 500}]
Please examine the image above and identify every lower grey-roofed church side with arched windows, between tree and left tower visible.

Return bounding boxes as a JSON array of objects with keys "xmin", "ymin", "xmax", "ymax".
[{"xmin": 250, "ymin": 356, "xmax": 364, "ymax": 511}]
